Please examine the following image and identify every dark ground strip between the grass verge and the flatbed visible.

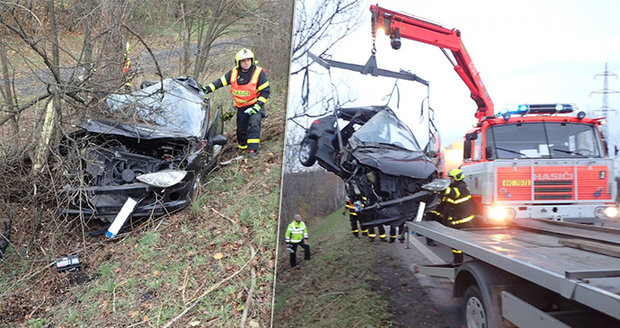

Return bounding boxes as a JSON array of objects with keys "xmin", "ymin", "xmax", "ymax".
[{"xmin": 374, "ymin": 234, "xmax": 464, "ymax": 328}]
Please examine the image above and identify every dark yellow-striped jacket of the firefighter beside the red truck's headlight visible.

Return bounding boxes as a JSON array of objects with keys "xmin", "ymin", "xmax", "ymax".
[{"xmin": 442, "ymin": 180, "xmax": 474, "ymax": 226}]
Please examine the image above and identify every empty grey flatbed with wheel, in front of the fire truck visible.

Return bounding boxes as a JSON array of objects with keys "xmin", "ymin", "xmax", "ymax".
[{"xmin": 407, "ymin": 219, "xmax": 620, "ymax": 328}]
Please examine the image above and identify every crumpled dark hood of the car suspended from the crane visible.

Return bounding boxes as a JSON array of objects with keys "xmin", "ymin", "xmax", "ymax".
[{"xmin": 352, "ymin": 147, "xmax": 436, "ymax": 179}]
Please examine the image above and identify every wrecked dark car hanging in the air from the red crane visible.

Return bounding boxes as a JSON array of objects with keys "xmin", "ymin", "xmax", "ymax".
[{"xmin": 299, "ymin": 106, "xmax": 439, "ymax": 226}]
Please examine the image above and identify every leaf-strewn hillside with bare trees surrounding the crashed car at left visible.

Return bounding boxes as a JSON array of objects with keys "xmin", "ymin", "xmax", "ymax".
[{"xmin": 0, "ymin": 0, "xmax": 292, "ymax": 327}]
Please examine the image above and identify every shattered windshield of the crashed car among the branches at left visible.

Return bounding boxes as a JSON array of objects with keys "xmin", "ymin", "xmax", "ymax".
[{"xmin": 106, "ymin": 79, "xmax": 207, "ymax": 137}]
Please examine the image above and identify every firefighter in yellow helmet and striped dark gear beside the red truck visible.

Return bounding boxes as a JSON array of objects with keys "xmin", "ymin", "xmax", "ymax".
[{"xmin": 427, "ymin": 169, "xmax": 474, "ymax": 264}]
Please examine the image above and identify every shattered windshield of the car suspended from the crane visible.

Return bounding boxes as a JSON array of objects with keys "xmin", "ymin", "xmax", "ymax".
[{"xmin": 351, "ymin": 110, "xmax": 421, "ymax": 151}]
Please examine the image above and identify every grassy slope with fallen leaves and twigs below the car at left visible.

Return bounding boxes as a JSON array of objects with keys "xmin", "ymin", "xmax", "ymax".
[{"xmin": 0, "ymin": 81, "xmax": 287, "ymax": 327}]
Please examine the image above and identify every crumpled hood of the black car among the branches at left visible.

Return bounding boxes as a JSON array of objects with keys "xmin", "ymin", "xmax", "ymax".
[{"xmin": 79, "ymin": 119, "xmax": 192, "ymax": 140}]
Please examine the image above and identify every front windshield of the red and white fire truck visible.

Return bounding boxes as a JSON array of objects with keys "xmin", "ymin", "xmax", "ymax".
[{"xmin": 486, "ymin": 122, "xmax": 603, "ymax": 159}]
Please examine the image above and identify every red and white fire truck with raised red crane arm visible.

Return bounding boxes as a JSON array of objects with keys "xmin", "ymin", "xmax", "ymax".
[{"xmin": 370, "ymin": 5, "xmax": 618, "ymax": 223}]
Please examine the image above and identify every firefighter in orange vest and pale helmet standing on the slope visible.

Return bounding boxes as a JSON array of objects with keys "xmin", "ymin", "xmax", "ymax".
[{"xmin": 203, "ymin": 48, "xmax": 270, "ymax": 157}]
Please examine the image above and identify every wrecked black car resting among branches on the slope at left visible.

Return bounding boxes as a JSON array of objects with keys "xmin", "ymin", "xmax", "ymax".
[{"xmin": 61, "ymin": 77, "xmax": 227, "ymax": 222}]
